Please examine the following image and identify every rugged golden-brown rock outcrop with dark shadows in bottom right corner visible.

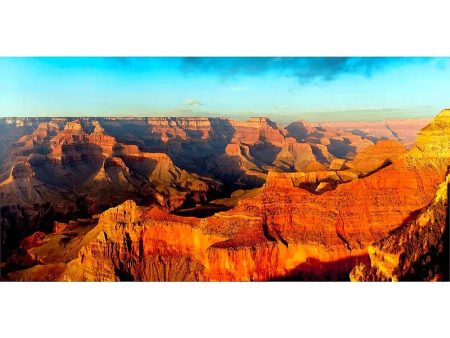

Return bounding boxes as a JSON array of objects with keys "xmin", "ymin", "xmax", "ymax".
[{"xmin": 350, "ymin": 175, "xmax": 450, "ymax": 281}]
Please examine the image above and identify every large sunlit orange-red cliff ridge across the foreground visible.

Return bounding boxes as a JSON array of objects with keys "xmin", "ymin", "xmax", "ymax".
[{"xmin": 24, "ymin": 160, "xmax": 442, "ymax": 281}]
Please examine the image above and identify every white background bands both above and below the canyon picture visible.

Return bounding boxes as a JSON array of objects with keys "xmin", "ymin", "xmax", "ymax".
[{"xmin": 0, "ymin": 0, "xmax": 450, "ymax": 337}]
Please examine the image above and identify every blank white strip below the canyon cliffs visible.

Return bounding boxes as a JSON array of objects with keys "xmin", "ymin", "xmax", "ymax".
[{"xmin": 0, "ymin": 282, "xmax": 450, "ymax": 338}]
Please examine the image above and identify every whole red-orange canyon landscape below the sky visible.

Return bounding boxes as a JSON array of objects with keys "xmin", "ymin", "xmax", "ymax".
[{"xmin": 0, "ymin": 110, "xmax": 450, "ymax": 281}]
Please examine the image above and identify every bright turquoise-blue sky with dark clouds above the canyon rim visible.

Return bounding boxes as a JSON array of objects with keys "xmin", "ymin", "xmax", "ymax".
[{"xmin": 0, "ymin": 57, "xmax": 450, "ymax": 121}]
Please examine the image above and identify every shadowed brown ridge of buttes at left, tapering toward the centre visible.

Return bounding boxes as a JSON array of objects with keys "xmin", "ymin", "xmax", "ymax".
[{"xmin": 0, "ymin": 120, "xmax": 221, "ymax": 266}]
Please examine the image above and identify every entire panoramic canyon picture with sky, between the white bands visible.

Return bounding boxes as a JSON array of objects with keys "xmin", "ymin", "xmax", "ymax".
[{"xmin": 0, "ymin": 57, "xmax": 450, "ymax": 282}]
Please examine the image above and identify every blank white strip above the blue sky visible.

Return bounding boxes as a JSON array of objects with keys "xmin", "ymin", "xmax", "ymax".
[{"xmin": 0, "ymin": 0, "xmax": 450, "ymax": 56}]
